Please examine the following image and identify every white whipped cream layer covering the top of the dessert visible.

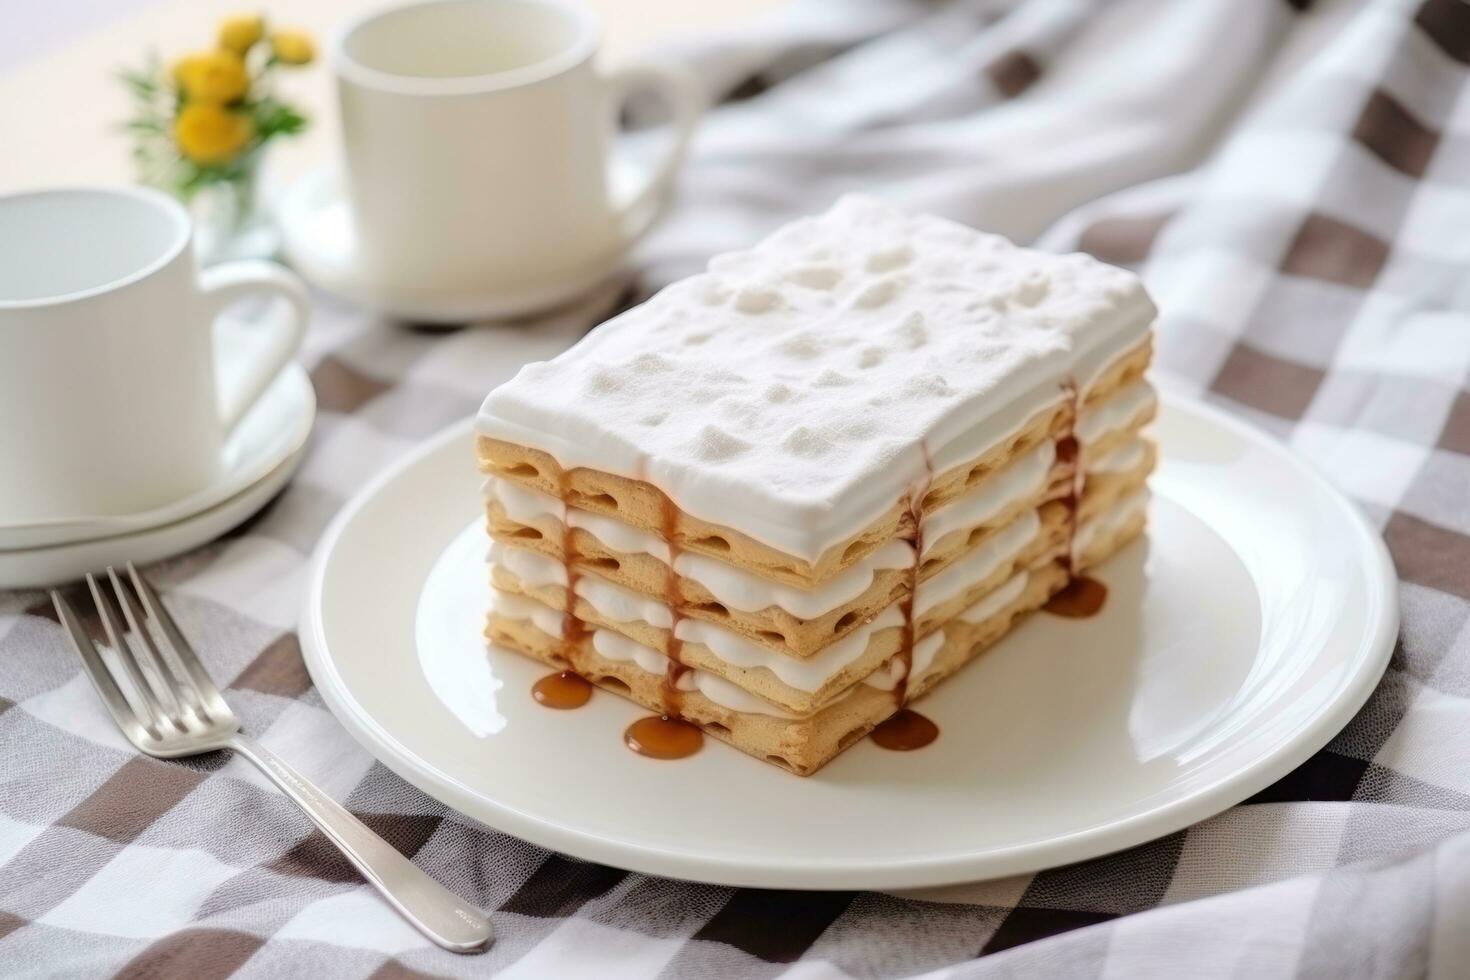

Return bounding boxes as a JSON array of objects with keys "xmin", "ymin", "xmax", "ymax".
[{"xmin": 478, "ymin": 197, "xmax": 1154, "ymax": 561}]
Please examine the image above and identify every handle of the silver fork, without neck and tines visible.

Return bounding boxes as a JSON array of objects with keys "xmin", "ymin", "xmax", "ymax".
[{"xmin": 229, "ymin": 735, "xmax": 495, "ymax": 952}]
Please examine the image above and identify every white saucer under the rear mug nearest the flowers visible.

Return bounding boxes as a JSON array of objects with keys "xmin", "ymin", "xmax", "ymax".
[{"xmin": 273, "ymin": 166, "xmax": 622, "ymax": 323}]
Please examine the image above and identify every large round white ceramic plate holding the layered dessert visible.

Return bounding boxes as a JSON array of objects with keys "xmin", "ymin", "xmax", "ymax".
[{"xmin": 301, "ymin": 398, "xmax": 1398, "ymax": 889}]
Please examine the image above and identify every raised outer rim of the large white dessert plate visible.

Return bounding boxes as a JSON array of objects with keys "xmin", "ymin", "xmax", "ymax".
[{"xmin": 298, "ymin": 386, "xmax": 1399, "ymax": 890}]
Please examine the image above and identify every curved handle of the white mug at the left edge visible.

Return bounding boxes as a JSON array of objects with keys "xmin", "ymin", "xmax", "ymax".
[{"xmin": 198, "ymin": 260, "xmax": 312, "ymax": 433}]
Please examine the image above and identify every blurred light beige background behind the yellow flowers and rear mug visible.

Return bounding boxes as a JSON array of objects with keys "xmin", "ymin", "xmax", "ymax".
[{"xmin": 0, "ymin": 0, "xmax": 781, "ymax": 192}]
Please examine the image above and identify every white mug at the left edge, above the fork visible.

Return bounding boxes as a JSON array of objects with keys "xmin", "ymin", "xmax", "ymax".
[{"xmin": 0, "ymin": 188, "xmax": 309, "ymax": 525}]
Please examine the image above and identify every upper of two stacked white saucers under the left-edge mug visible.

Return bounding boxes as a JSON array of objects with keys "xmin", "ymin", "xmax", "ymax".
[{"xmin": 0, "ymin": 323, "xmax": 316, "ymax": 557}]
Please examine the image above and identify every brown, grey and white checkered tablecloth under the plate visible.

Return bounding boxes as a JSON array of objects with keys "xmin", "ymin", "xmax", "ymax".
[{"xmin": 0, "ymin": 0, "xmax": 1470, "ymax": 977}]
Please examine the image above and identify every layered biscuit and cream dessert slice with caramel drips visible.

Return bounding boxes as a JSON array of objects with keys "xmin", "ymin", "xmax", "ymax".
[{"xmin": 476, "ymin": 197, "xmax": 1157, "ymax": 774}]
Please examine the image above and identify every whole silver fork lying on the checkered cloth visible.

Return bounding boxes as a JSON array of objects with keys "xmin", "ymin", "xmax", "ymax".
[{"xmin": 51, "ymin": 561, "xmax": 494, "ymax": 952}]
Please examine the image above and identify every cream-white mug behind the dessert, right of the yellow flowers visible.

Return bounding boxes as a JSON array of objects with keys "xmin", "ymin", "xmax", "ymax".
[{"xmin": 332, "ymin": 0, "xmax": 703, "ymax": 313}]
